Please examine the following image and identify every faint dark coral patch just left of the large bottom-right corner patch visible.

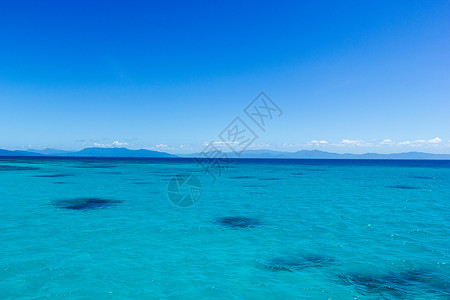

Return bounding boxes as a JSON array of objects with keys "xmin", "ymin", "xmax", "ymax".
[{"xmin": 264, "ymin": 254, "xmax": 335, "ymax": 272}]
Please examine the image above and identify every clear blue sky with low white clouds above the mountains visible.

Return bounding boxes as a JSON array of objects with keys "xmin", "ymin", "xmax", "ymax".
[{"xmin": 0, "ymin": 0, "xmax": 450, "ymax": 153}]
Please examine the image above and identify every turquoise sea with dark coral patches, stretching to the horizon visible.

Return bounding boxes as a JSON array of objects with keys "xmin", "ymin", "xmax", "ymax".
[{"xmin": 0, "ymin": 158, "xmax": 450, "ymax": 299}]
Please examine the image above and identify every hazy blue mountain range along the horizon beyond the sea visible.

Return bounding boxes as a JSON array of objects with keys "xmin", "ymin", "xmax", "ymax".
[{"xmin": 0, "ymin": 148, "xmax": 450, "ymax": 159}]
